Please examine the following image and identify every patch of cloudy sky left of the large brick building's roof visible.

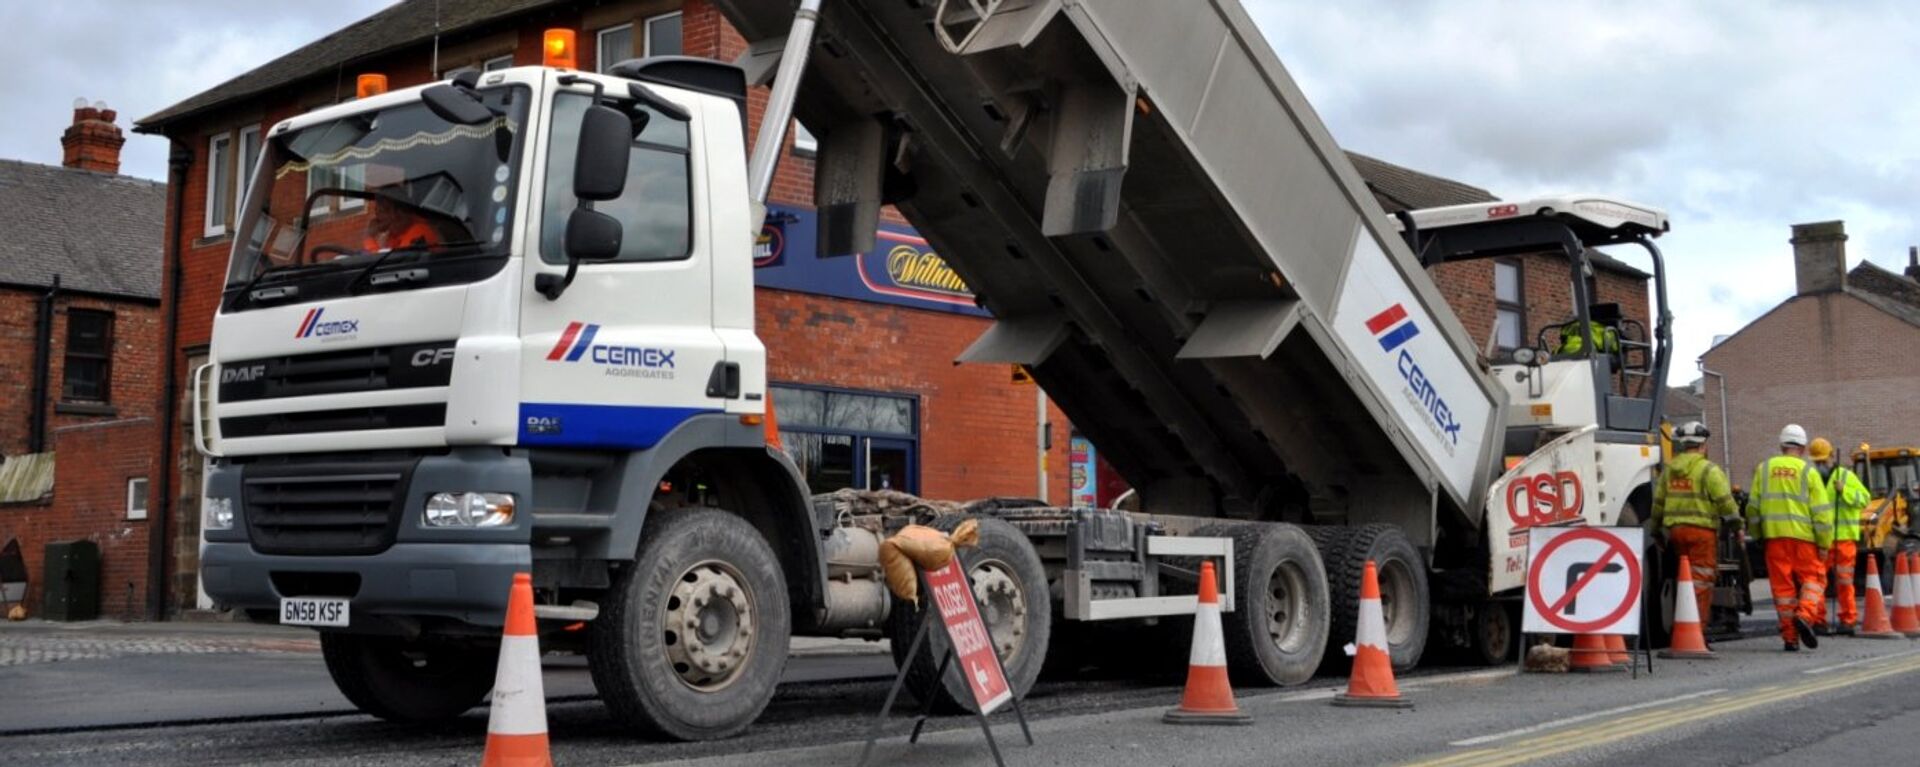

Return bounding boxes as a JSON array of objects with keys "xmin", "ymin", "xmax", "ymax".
[{"xmin": 0, "ymin": 0, "xmax": 394, "ymax": 179}]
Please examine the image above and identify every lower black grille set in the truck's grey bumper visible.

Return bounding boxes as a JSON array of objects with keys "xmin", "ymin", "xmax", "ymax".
[{"xmin": 240, "ymin": 459, "xmax": 415, "ymax": 554}]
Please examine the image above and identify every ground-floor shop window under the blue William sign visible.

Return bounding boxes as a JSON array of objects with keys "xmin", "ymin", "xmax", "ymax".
[{"xmin": 770, "ymin": 384, "xmax": 920, "ymax": 492}]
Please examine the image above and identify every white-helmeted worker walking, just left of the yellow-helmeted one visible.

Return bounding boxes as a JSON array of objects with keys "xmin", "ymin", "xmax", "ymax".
[{"xmin": 1747, "ymin": 423, "xmax": 1834, "ymax": 652}]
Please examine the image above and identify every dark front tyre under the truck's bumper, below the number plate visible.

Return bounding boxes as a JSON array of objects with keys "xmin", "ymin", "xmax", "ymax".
[{"xmin": 321, "ymin": 632, "xmax": 499, "ymax": 723}]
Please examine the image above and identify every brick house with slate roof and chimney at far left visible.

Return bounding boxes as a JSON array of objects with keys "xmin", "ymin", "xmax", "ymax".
[{"xmin": 0, "ymin": 102, "xmax": 165, "ymax": 617}]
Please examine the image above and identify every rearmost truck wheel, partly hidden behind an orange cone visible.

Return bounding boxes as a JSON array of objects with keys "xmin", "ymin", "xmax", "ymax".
[{"xmin": 1327, "ymin": 525, "xmax": 1432, "ymax": 671}]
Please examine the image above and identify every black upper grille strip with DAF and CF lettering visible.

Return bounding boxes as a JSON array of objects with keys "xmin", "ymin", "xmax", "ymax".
[{"xmin": 221, "ymin": 340, "xmax": 453, "ymax": 402}]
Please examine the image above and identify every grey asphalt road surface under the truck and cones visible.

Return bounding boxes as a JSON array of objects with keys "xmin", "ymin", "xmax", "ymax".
[{"xmin": 0, "ymin": 622, "xmax": 1920, "ymax": 767}]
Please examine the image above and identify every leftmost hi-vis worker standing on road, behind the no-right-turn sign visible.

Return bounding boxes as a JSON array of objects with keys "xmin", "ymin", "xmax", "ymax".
[{"xmin": 1647, "ymin": 421, "xmax": 1740, "ymax": 634}]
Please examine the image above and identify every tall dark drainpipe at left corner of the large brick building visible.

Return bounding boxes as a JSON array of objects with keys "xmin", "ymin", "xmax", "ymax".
[{"xmin": 146, "ymin": 140, "xmax": 194, "ymax": 621}]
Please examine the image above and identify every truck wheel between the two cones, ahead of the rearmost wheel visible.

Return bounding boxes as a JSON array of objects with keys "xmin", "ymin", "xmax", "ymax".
[{"xmin": 1194, "ymin": 523, "xmax": 1329, "ymax": 684}]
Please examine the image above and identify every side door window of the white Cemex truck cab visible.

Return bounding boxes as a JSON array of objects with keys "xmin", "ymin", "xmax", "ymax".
[{"xmin": 540, "ymin": 92, "xmax": 693, "ymax": 263}]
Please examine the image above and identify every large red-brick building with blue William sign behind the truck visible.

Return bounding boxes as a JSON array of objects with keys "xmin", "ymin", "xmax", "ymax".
[{"xmin": 138, "ymin": 0, "xmax": 1645, "ymax": 611}]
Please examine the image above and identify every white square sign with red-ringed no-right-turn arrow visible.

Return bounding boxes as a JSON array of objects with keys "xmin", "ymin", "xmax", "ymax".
[{"xmin": 1521, "ymin": 527, "xmax": 1645, "ymax": 634}]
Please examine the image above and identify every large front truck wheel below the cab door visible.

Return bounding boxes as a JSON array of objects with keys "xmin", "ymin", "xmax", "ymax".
[{"xmin": 588, "ymin": 507, "xmax": 791, "ymax": 740}]
